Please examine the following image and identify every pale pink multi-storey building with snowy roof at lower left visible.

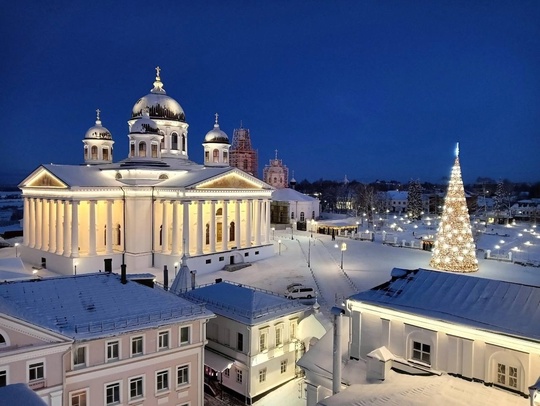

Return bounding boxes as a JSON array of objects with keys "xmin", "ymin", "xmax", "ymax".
[{"xmin": 0, "ymin": 272, "xmax": 214, "ymax": 406}]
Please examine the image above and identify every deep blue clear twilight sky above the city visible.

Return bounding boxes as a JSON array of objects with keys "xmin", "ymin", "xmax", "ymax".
[{"xmin": 0, "ymin": 0, "xmax": 540, "ymax": 183}]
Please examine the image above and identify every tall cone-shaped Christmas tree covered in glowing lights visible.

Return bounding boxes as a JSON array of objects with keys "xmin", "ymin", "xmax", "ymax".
[{"xmin": 430, "ymin": 145, "xmax": 478, "ymax": 272}]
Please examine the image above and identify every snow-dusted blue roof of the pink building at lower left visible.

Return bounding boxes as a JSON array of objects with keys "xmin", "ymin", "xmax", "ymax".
[{"xmin": 0, "ymin": 272, "xmax": 212, "ymax": 340}]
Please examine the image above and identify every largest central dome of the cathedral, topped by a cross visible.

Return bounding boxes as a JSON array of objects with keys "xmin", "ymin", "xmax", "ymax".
[{"xmin": 131, "ymin": 66, "xmax": 186, "ymax": 122}]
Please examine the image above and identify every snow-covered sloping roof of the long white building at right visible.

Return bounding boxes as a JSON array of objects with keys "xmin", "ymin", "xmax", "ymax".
[{"xmin": 350, "ymin": 268, "xmax": 540, "ymax": 340}]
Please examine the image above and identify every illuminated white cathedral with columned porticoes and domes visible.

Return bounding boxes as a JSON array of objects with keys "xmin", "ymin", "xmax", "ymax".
[{"xmin": 19, "ymin": 67, "xmax": 274, "ymax": 274}]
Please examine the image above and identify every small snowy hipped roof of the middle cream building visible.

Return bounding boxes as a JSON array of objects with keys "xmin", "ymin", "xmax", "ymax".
[{"xmin": 182, "ymin": 281, "xmax": 307, "ymax": 326}]
